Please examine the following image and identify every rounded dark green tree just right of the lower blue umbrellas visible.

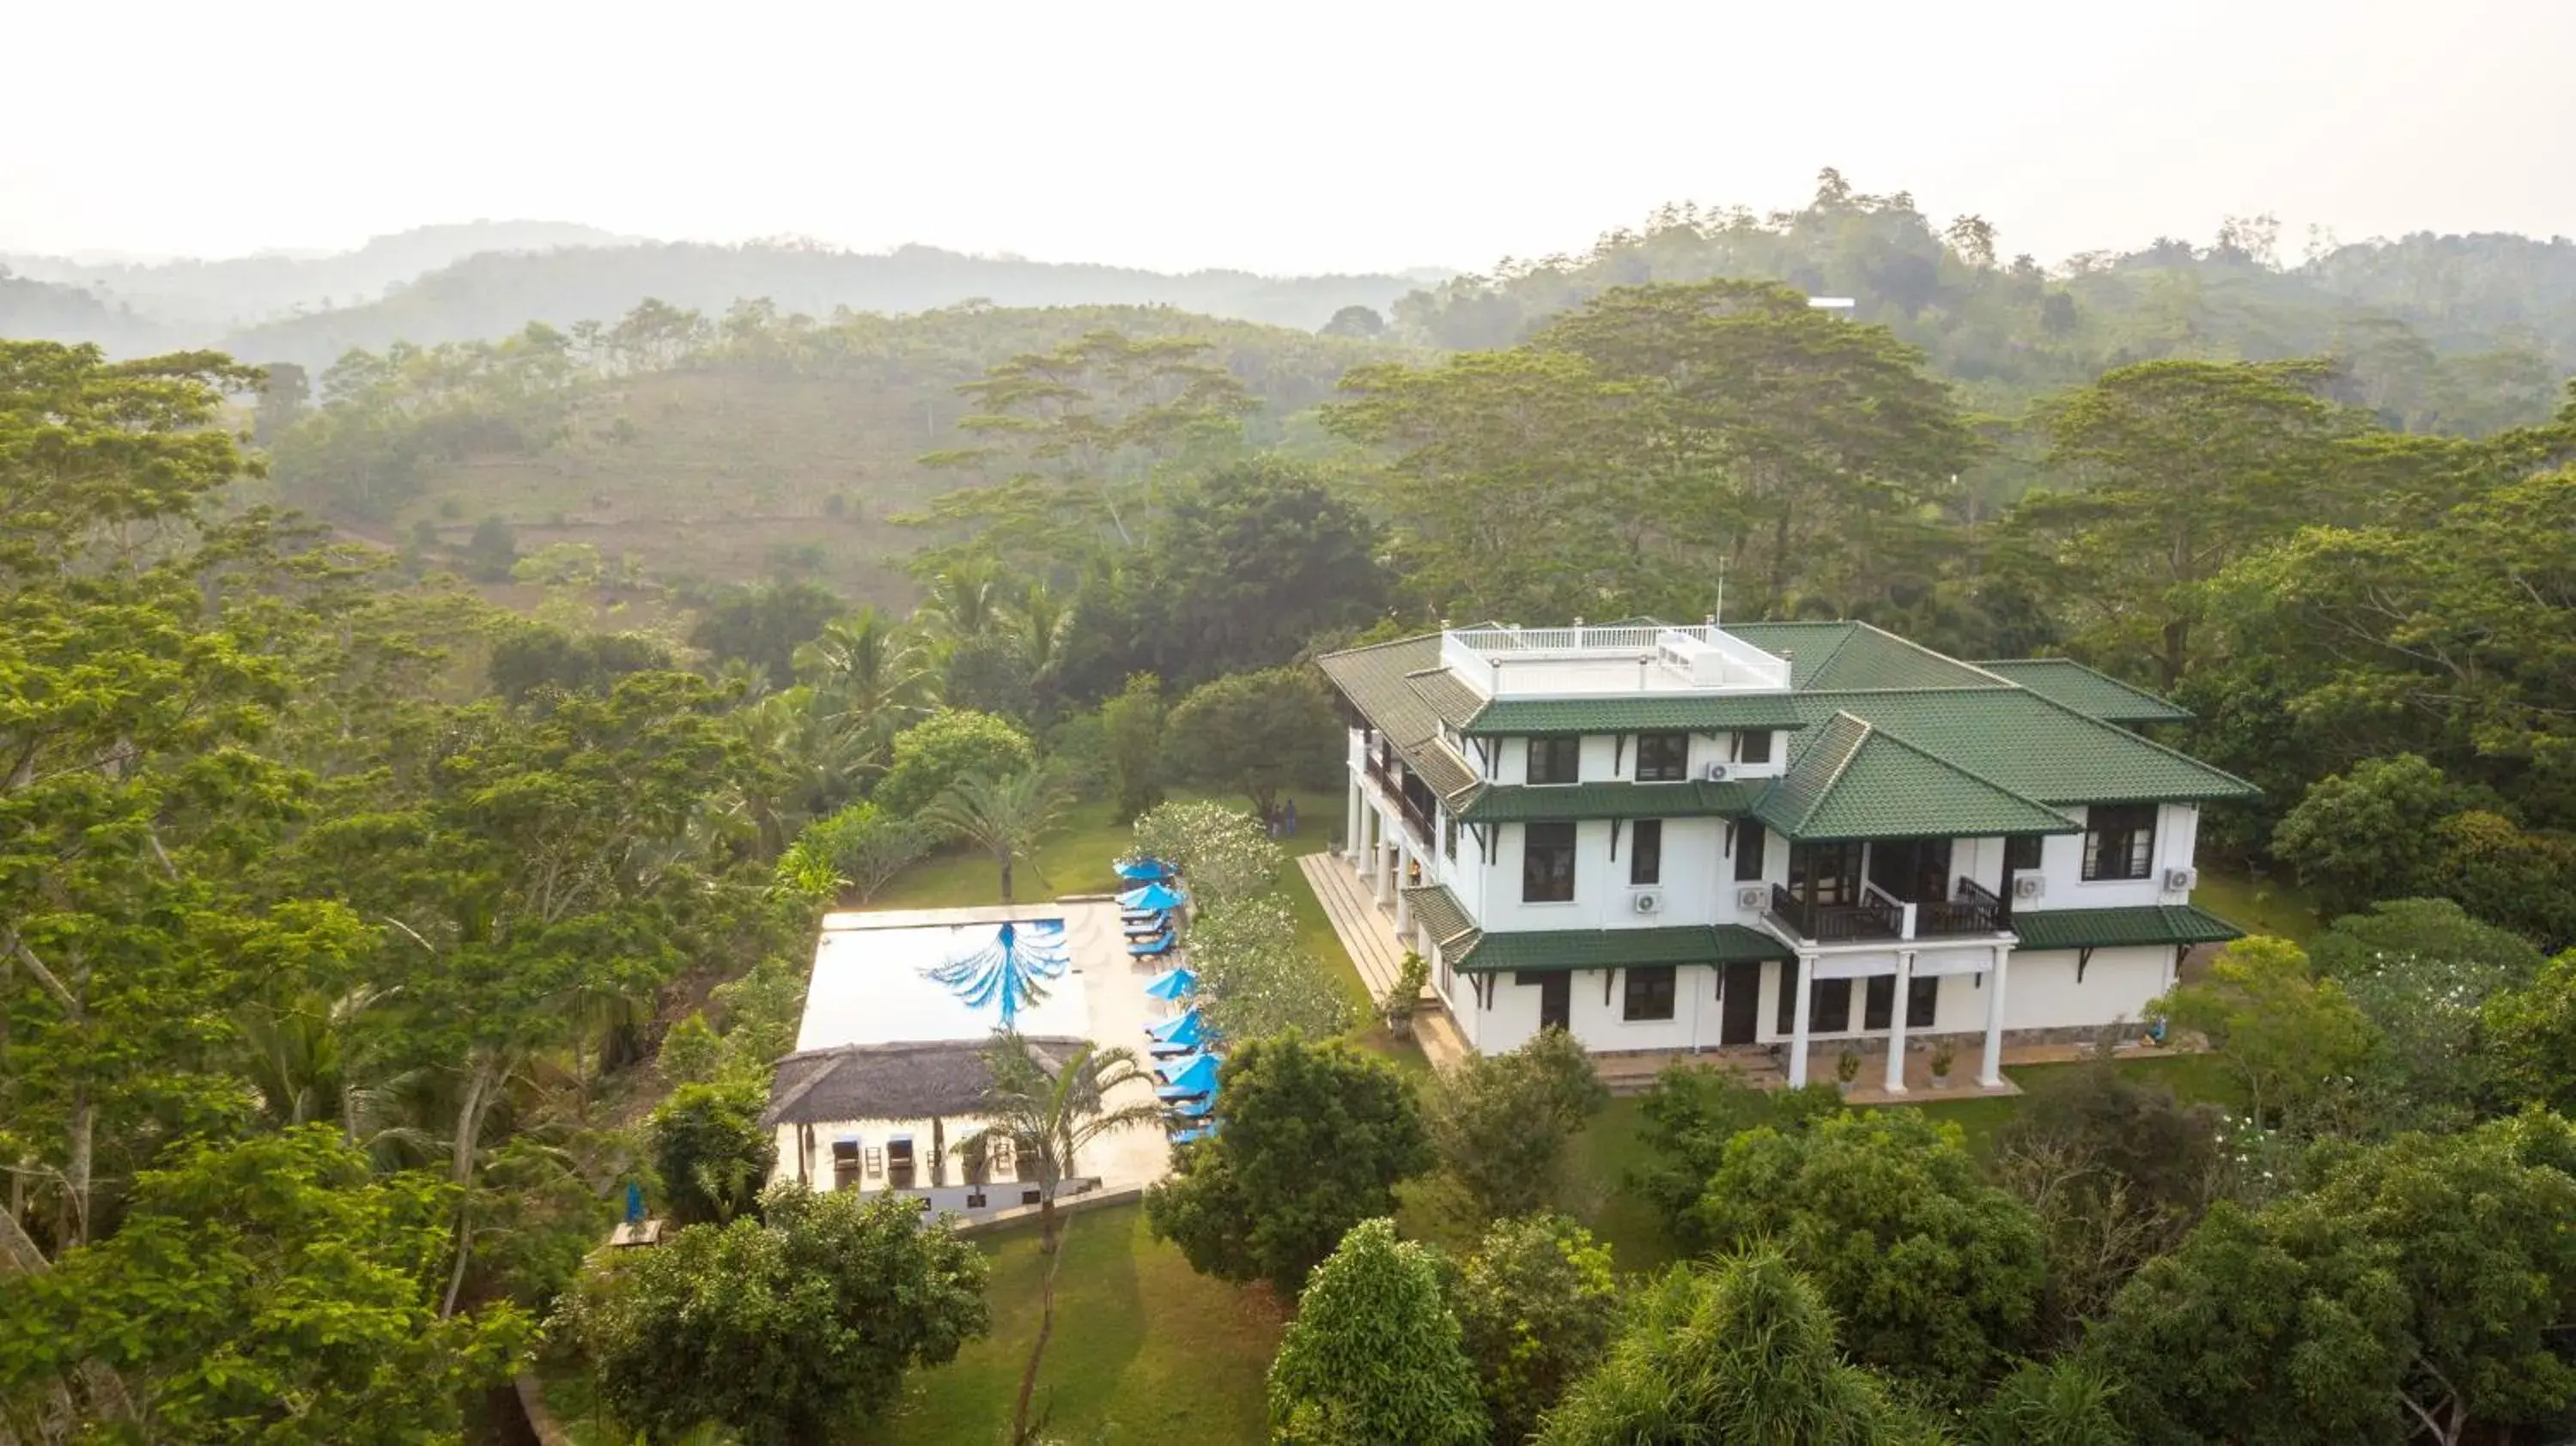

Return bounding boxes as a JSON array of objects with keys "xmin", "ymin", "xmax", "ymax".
[{"xmin": 1146, "ymin": 1034, "xmax": 1430, "ymax": 1299}]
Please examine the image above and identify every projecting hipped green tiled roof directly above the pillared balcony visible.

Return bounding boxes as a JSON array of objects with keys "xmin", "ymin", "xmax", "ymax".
[{"xmin": 1757, "ymin": 711, "xmax": 2081, "ymax": 841}]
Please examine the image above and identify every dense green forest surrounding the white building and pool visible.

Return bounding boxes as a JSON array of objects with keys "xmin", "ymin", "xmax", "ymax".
[{"xmin": 15, "ymin": 173, "xmax": 2576, "ymax": 1446}]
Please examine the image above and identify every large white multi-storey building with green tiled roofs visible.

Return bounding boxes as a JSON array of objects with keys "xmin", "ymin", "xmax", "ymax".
[{"xmin": 1321, "ymin": 621, "xmax": 2254, "ymax": 1091}]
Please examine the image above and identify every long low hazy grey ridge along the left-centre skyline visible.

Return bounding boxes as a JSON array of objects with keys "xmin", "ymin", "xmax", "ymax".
[{"xmin": 222, "ymin": 245, "xmax": 1417, "ymax": 368}]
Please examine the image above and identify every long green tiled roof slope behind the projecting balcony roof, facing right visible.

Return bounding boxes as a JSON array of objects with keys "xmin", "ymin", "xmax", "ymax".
[{"xmin": 1793, "ymin": 685, "xmax": 2257, "ymax": 807}]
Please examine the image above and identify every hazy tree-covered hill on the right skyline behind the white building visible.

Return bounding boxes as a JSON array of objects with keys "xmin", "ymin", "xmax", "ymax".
[{"xmin": 1396, "ymin": 170, "xmax": 2576, "ymax": 435}]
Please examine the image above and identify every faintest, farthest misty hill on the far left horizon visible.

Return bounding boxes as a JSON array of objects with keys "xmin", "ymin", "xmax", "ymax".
[{"xmin": 0, "ymin": 222, "xmax": 634, "ymax": 332}]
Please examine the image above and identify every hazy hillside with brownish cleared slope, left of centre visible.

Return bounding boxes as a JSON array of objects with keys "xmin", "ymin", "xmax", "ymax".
[{"xmin": 263, "ymin": 307, "xmax": 1404, "ymax": 603}]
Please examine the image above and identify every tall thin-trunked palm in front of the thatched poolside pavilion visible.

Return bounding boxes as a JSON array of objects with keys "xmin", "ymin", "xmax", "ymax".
[{"xmin": 956, "ymin": 1031, "xmax": 1162, "ymax": 1446}]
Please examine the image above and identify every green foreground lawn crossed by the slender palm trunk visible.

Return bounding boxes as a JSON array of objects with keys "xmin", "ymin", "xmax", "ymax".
[{"xmin": 850, "ymin": 1206, "xmax": 1280, "ymax": 1446}]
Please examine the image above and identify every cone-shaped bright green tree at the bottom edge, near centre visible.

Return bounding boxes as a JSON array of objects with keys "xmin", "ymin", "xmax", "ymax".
[{"xmin": 1270, "ymin": 1219, "xmax": 1492, "ymax": 1446}]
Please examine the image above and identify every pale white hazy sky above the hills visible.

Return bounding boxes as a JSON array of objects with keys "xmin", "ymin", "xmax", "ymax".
[{"xmin": 0, "ymin": 0, "xmax": 2576, "ymax": 270}]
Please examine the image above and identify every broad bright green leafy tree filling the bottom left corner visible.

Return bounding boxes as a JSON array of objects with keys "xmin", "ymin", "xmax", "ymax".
[{"xmin": 0, "ymin": 1124, "xmax": 531, "ymax": 1446}]
